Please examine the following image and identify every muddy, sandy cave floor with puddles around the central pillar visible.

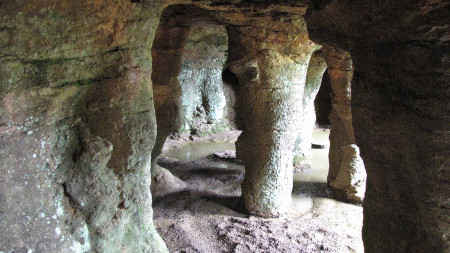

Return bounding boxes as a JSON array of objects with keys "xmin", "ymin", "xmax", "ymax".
[{"xmin": 153, "ymin": 130, "xmax": 364, "ymax": 253}]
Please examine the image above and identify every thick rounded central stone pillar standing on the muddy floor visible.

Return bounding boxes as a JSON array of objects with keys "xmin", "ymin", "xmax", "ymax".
[{"xmin": 229, "ymin": 24, "xmax": 315, "ymax": 217}]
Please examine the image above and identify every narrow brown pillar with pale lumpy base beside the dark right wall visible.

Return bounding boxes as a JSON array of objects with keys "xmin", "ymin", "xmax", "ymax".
[{"xmin": 322, "ymin": 46, "xmax": 365, "ymax": 202}]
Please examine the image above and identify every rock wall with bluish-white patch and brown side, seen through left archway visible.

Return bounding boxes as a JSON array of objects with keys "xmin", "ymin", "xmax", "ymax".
[{"xmin": 152, "ymin": 5, "xmax": 234, "ymax": 178}]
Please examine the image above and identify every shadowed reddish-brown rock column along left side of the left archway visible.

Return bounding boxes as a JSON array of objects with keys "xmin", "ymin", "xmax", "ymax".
[{"xmin": 152, "ymin": 8, "xmax": 189, "ymax": 176}]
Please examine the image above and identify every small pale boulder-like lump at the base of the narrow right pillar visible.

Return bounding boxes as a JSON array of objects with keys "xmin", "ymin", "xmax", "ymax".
[{"xmin": 330, "ymin": 144, "xmax": 366, "ymax": 203}]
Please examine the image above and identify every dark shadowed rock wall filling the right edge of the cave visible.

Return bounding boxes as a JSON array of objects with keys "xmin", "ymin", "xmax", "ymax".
[{"xmin": 307, "ymin": 0, "xmax": 450, "ymax": 252}]
